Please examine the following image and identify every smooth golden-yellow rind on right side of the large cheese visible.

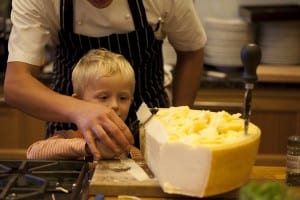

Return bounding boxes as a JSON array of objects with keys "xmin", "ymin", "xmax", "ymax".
[{"xmin": 204, "ymin": 130, "xmax": 260, "ymax": 196}]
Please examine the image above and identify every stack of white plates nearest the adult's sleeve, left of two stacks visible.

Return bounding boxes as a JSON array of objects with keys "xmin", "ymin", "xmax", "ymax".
[{"xmin": 204, "ymin": 18, "xmax": 254, "ymax": 67}]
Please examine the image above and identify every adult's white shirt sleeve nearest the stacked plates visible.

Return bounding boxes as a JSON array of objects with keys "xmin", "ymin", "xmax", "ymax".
[{"xmin": 162, "ymin": 0, "xmax": 207, "ymax": 51}]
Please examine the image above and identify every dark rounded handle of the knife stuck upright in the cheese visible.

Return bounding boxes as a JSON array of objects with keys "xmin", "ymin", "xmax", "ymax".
[{"xmin": 241, "ymin": 44, "xmax": 261, "ymax": 84}]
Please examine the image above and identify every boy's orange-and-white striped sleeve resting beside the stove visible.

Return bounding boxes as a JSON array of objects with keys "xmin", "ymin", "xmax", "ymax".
[{"xmin": 27, "ymin": 132, "xmax": 88, "ymax": 160}]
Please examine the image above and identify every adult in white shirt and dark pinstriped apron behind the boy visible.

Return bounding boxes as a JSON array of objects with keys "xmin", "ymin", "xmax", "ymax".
[{"xmin": 4, "ymin": 0, "xmax": 206, "ymax": 159}]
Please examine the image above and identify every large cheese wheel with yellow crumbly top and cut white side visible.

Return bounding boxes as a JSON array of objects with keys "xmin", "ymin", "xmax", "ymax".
[{"xmin": 141, "ymin": 106, "xmax": 260, "ymax": 197}]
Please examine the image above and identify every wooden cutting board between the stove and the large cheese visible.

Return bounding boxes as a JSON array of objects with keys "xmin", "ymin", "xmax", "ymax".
[{"xmin": 89, "ymin": 158, "xmax": 178, "ymax": 197}]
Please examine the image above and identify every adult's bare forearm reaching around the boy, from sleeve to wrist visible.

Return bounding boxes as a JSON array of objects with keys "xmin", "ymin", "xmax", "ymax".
[{"xmin": 4, "ymin": 62, "xmax": 78, "ymax": 122}]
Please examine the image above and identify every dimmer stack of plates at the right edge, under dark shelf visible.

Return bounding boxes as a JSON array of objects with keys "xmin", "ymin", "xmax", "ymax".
[{"xmin": 259, "ymin": 21, "xmax": 300, "ymax": 65}]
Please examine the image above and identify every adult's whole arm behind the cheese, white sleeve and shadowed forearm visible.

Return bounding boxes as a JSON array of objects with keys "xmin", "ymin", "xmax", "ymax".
[{"xmin": 162, "ymin": 0, "xmax": 206, "ymax": 106}]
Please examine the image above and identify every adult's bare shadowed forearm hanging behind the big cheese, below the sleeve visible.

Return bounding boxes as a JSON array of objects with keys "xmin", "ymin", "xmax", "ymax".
[{"xmin": 173, "ymin": 49, "xmax": 203, "ymax": 107}]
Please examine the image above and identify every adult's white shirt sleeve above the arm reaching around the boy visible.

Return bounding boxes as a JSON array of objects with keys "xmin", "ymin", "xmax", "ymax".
[{"xmin": 8, "ymin": 0, "xmax": 59, "ymax": 66}]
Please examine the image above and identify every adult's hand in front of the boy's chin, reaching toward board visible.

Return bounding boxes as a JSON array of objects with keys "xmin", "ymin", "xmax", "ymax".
[{"xmin": 73, "ymin": 102, "xmax": 134, "ymax": 160}]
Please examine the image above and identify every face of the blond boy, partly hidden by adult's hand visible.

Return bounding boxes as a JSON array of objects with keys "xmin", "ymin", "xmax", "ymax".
[{"xmin": 82, "ymin": 75, "xmax": 133, "ymax": 121}]
